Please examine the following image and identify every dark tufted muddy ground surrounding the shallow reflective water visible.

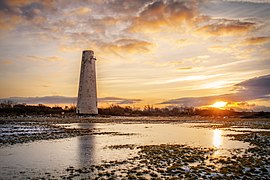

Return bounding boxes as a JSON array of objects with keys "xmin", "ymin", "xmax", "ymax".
[{"xmin": 0, "ymin": 116, "xmax": 270, "ymax": 179}]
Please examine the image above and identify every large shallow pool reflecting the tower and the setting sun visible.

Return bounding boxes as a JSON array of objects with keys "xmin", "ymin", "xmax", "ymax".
[{"xmin": 0, "ymin": 123, "xmax": 252, "ymax": 178}]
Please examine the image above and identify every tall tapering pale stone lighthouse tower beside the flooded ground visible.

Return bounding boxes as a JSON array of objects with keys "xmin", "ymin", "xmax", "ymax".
[{"xmin": 76, "ymin": 50, "xmax": 98, "ymax": 115}]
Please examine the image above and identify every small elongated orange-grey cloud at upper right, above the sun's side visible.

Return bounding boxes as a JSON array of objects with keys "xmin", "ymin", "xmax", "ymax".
[{"xmin": 197, "ymin": 19, "xmax": 256, "ymax": 36}]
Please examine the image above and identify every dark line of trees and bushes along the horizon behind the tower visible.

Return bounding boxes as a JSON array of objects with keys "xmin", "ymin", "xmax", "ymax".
[{"xmin": 0, "ymin": 102, "xmax": 270, "ymax": 118}]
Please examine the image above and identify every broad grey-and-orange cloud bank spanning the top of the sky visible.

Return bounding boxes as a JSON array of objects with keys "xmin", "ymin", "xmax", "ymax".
[{"xmin": 0, "ymin": 0, "xmax": 264, "ymax": 41}]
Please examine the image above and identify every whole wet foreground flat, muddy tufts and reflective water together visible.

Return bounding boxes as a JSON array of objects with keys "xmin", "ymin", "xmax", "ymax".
[{"xmin": 0, "ymin": 117, "xmax": 270, "ymax": 179}]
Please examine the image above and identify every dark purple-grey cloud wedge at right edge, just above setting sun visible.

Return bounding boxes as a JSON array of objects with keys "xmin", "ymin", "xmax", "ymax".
[{"xmin": 160, "ymin": 74, "xmax": 270, "ymax": 107}]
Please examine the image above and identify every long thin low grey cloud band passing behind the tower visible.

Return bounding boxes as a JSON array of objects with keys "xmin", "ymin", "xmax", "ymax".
[{"xmin": 0, "ymin": 96, "xmax": 142, "ymax": 104}]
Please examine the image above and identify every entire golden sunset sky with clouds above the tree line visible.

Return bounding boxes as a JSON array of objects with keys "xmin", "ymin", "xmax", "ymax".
[{"xmin": 0, "ymin": 0, "xmax": 270, "ymax": 111}]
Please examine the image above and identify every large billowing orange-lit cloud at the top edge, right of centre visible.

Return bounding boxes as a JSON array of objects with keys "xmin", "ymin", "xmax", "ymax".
[{"xmin": 125, "ymin": 1, "xmax": 200, "ymax": 32}]
